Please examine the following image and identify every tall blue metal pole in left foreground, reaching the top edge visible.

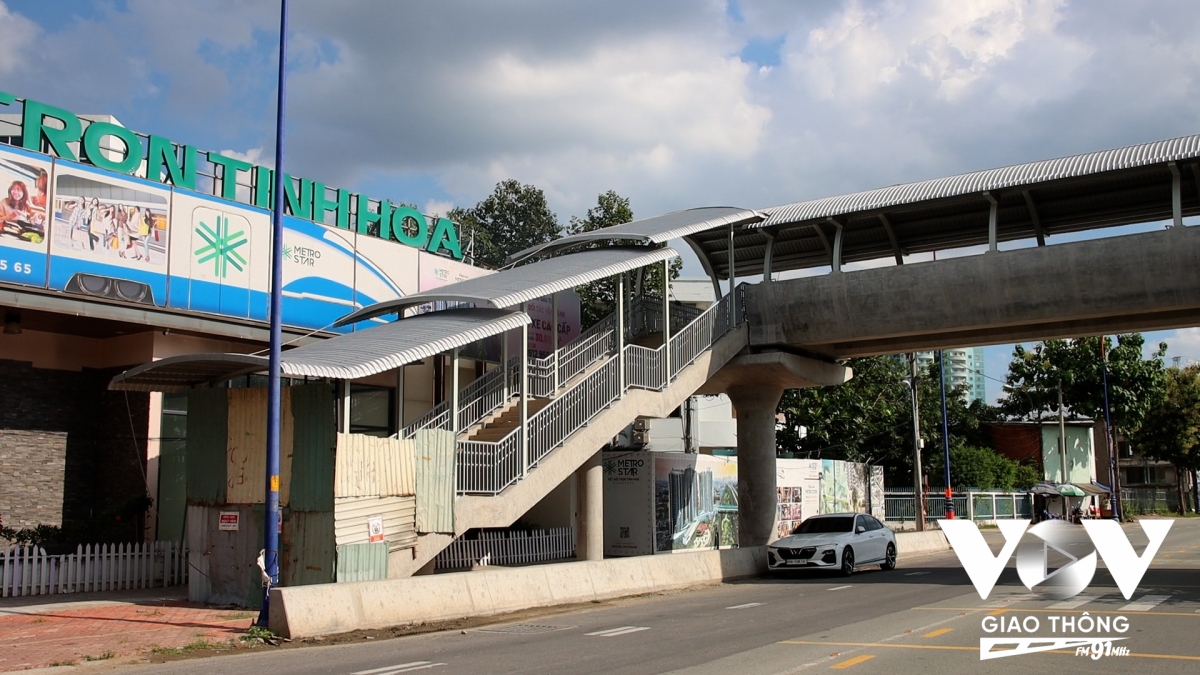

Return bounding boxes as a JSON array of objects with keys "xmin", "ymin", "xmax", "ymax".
[{"xmin": 257, "ymin": 0, "xmax": 288, "ymax": 627}]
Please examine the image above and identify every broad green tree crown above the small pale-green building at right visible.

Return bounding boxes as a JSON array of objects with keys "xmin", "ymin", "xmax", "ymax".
[{"xmin": 1000, "ymin": 333, "xmax": 1166, "ymax": 432}]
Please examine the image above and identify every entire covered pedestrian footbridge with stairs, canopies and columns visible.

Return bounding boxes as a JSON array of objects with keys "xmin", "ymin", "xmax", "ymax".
[{"xmin": 112, "ymin": 136, "xmax": 1200, "ymax": 586}]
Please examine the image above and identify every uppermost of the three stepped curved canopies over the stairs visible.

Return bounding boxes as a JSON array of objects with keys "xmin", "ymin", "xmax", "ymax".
[{"xmin": 506, "ymin": 207, "xmax": 767, "ymax": 265}]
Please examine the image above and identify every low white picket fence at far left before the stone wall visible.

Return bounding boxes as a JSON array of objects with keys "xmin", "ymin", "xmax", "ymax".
[{"xmin": 0, "ymin": 542, "xmax": 187, "ymax": 598}]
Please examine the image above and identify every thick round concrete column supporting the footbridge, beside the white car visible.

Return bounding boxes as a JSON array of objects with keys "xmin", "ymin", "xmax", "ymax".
[{"xmin": 728, "ymin": 383, "xmax": 784, "ymax": 546}]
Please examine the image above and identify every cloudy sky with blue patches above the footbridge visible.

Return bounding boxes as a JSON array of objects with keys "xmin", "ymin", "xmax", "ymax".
[{"xmin": 0, "ymin": 0, "xmax": 1200, "ymax": 399}]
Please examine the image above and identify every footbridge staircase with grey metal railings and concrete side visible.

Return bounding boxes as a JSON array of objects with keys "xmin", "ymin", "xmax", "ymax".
[{"xmin": 401, "ymin": 285, "xmax": 746, "ymax": 575}]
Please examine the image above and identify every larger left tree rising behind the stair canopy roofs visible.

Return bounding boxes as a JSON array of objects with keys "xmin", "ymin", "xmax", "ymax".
[{"xmin": 446, "ymin": 179, "xmax": 562, "ymax": 268}]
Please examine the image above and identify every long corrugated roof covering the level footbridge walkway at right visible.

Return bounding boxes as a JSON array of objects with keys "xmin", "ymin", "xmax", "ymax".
[{"xmin": 690, "ymin": 136, "xmax": 1200, "ymax": 276}]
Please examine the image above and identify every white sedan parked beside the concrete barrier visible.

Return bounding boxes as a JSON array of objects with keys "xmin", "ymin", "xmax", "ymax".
[{"xmin": 767, "ymin": 513, "xmax": 896, "ymax": 569}]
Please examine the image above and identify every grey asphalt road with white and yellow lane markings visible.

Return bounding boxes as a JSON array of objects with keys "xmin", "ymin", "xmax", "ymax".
[{"xmin": 114, "ymin": 519, "xmax": 1200, "ymax": 675}]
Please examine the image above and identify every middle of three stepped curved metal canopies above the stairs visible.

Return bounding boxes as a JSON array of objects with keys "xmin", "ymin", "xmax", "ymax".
[{"xmin": 335, "ymin": 246, "xmax": 679, "ymax": 325}]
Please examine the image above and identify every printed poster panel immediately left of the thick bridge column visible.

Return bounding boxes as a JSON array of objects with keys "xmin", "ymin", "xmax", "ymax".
[{"xmin": 654, "ymin": 453, "xmax": 738, "ymax": 551}]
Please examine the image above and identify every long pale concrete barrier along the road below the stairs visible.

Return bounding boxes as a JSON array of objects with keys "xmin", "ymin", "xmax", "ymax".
[{"xmin": 270, "ymin": 547, "xmax": 763, "ymax": 638}]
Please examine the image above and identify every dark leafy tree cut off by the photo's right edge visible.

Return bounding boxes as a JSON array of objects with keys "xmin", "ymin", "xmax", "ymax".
[{"xmin": 1130, "ymin": 365, "xmax": 1200, "ymax": 515}]
